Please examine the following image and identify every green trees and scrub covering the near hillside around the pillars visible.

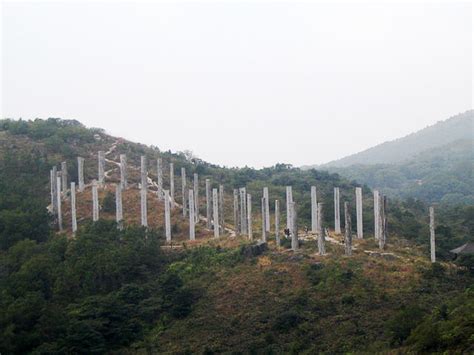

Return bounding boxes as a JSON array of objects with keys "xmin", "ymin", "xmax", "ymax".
[{"xmin": 0, "ymin": 119, "xmax": 474, "ymax": 354}]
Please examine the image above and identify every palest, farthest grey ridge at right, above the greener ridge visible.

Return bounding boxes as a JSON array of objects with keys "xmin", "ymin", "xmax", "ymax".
[{"xmin": 319, "ymin": 110, "xmax": 474, "ymax": 168}]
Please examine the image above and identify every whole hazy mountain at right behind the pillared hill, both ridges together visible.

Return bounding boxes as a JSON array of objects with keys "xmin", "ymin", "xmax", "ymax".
[{"xmin": 304, "ymin": 110, "xmax": 474, "ymax": 205}]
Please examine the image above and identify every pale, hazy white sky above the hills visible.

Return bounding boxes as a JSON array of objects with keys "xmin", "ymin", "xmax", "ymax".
[{"xmin": 0, "ymin": 0, "xmax": 473, "ymax": 167}]
